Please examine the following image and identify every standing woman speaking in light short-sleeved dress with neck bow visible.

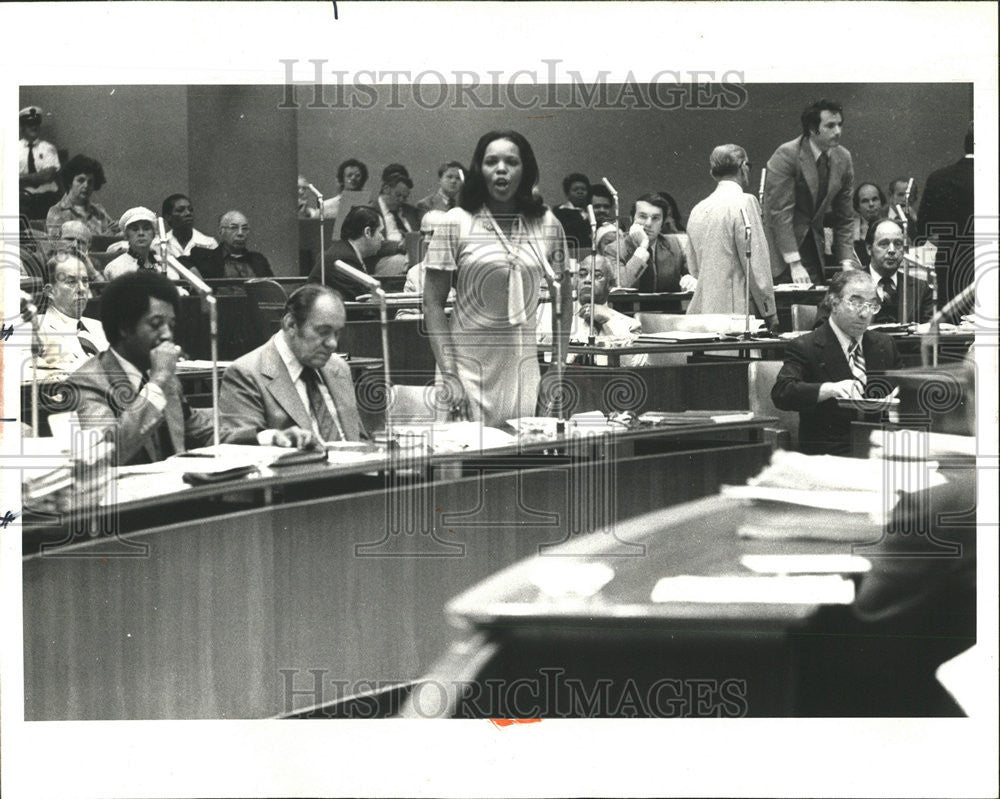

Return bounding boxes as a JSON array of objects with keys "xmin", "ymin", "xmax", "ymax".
[{"xmin": 424, "ymin": 131, "xmax": 573, "ymax": 427}]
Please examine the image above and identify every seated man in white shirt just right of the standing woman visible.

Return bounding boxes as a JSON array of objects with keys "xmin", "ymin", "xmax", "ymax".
[{"xmin": 535, "ymin": 255, "xmax": 649, "ymax": 368}]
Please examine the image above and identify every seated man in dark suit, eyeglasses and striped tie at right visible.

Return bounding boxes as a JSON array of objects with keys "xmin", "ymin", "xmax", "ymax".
[{"xmin": 771, "ymin": 270, "xmax": 899, "ymax": 455}]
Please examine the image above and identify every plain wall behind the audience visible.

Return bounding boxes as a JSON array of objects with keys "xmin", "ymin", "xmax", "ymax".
[{"xmin": 21, "ymin": 83, "xmax": 972, "ymax": 274}]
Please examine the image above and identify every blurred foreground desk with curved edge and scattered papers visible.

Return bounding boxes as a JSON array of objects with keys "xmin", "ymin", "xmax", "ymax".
[{"xmin": 410, "ymin": 496, "xmax": 881, "ymax": 718}]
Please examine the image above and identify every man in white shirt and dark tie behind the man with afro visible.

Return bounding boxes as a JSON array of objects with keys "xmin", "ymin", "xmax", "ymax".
[{"xmin": 38, "ymin": 252, "xmax": 108, "ymax": 372}]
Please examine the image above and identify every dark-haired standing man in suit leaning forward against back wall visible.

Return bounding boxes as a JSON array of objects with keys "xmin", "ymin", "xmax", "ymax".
[{"xmin": 764, "ymin": 100, "xmax": 854, "ymax": 283}]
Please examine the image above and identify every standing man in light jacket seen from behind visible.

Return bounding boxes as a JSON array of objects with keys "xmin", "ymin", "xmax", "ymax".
[{"xmin": 687, "ymin": 144, "xmax": 778, "ymax": 330}]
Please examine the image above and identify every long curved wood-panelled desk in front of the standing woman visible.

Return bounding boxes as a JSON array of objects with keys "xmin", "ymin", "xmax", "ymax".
[{"xmin": 23, "ymin": 419, "xmax": 770, "ymax": 720}]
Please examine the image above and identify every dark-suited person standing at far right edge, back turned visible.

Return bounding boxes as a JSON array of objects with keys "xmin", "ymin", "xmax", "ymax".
[{"xmin": 917, "ymin": 122, "xmax": 975, "ymax": 305}]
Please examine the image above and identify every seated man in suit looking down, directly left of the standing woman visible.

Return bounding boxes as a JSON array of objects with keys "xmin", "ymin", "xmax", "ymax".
[{"xmin": 219, "ymin": 283, "xmax": 362, "ymax": 446}]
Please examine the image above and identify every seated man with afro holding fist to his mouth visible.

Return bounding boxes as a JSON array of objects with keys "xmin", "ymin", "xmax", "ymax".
[{"xmin": 68, "ymin": 270, "xmax": 221, "ymax": 466}]
